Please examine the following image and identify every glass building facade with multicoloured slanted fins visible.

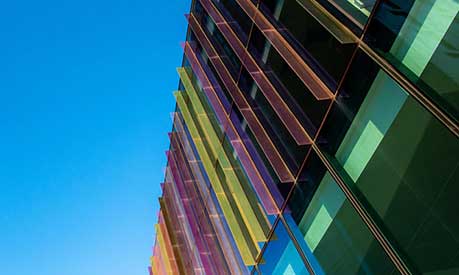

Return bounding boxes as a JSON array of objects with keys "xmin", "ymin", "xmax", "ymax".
[{"xmin": 150, "ymin": 0, "xmax": 459, "ymax": 275}]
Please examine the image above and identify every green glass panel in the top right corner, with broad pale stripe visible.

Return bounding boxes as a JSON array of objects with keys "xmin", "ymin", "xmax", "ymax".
[{"xmin": 365, "ymin": 0, "xmax": 459, "ymax": 121}]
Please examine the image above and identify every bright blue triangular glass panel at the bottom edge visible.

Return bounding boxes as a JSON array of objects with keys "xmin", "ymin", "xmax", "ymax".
[{"xmin": 258, "ymin": 221, "xmax": 309, "ymax": 274}]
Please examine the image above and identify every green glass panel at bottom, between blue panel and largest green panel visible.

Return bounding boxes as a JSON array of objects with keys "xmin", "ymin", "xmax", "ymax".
[{"xmin": 283, "ymin": 152, "xmax": 394, "ymax": 275}]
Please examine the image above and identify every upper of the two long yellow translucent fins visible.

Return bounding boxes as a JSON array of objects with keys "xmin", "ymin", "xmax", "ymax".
[{"xmin": 177, "ymin": 68, "xmax": 269, "ymax": 241}]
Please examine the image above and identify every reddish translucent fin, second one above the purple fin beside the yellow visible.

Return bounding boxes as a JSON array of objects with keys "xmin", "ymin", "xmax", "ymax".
[{"xmin": 200, "ymin": 0, "xmax": 311, "ymax": 145}]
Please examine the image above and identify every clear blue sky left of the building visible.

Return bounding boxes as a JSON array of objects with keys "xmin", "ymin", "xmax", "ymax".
[{"xmin": 0, "ymin": 0, "xmax": 190, "ymax": 275}]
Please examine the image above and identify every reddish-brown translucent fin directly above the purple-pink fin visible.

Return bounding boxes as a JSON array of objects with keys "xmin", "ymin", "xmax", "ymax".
[{"xmin": 187, "ymin": 14, "xmax": 294, "ymax": 182}]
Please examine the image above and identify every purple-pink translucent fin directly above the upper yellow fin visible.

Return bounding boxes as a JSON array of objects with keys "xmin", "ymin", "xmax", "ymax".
[{"xmin": 184, "ymin": 42, "xmax": 279, "ymax": 215}]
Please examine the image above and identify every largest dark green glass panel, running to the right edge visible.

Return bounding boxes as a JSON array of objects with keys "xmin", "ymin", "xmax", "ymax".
[{"xmin": 322, "ymin": 50, "xmax": 459, "ymax": 274}]
